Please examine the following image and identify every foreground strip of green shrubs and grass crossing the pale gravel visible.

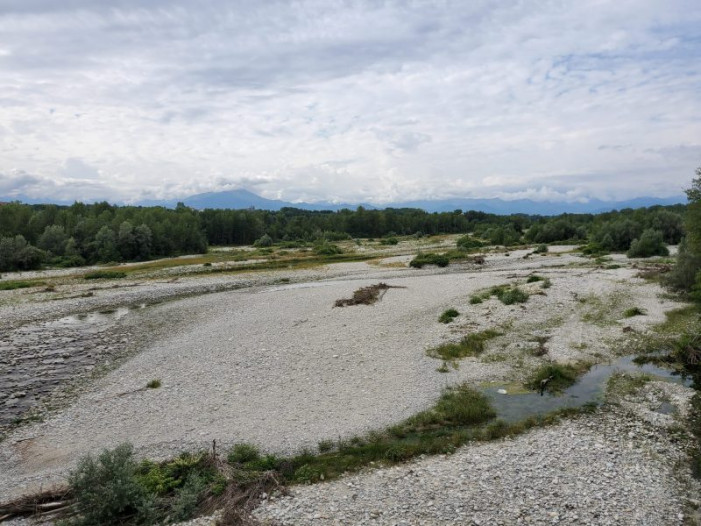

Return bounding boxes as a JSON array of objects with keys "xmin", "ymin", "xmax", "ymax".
[{"xmin": 0, "ymin": 385, "xmax": 592, "ymax": 526}]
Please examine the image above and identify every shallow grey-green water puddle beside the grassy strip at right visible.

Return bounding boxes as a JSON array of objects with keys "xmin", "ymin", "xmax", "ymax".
[{"xmin": 483, "ymin": 356, "xmax": 692, "ymax": 422}]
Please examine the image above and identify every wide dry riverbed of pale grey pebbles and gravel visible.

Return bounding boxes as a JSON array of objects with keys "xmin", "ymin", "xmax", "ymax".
[{"xmin": 0, "ymin": 247, "xmax": 698, "ymax": 524}]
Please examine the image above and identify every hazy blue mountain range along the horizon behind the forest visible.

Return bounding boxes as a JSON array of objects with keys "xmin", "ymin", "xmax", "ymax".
[{"xmin": 0, "ymin": 189, "xmax": 686, "ymax": 215}]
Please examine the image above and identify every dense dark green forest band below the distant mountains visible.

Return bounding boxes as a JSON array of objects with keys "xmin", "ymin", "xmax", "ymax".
[{"xmin": 0, "ymin": 198, "xmax": 686, "ymax": 270}]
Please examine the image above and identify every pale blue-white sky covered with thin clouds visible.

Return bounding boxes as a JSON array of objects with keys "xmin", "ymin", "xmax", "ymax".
[{"xmin": 0, "ymin": 0, "xmax": 701, "ymax": 203}]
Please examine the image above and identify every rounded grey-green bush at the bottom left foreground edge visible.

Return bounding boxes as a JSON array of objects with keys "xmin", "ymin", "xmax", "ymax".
[{"xmin": 68, "ymin": 444, "xmax": 153, "ymax": 525}]
